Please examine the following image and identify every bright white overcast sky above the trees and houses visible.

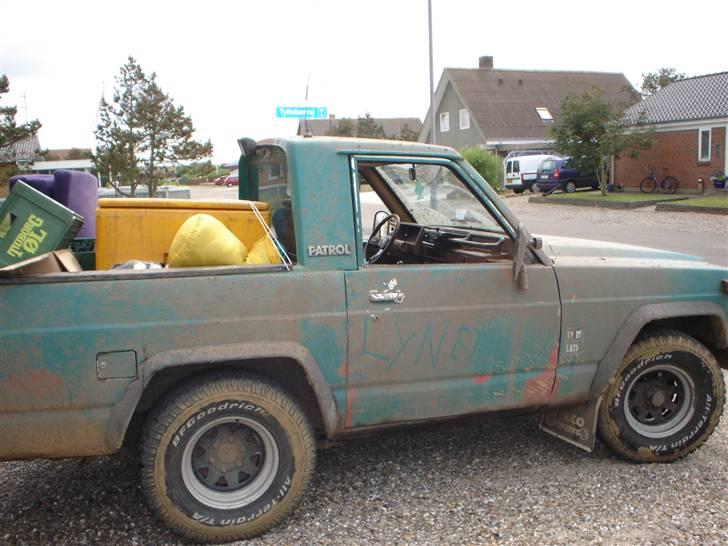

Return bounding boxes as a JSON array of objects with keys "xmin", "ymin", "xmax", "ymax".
[{"xmin": 0, "ymin": 0, "xmax": 728, "ymax": 162}]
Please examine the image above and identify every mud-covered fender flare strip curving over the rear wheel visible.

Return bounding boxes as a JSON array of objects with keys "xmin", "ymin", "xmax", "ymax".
[{"xmin": 106, "ymin": 341, "xmax": 338, "ymax": 449}]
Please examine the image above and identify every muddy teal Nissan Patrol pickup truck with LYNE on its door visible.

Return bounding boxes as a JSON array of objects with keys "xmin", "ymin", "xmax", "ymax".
[{"xmin": 0, "ymin": 137, "xmax": 728, "ymax": 542}]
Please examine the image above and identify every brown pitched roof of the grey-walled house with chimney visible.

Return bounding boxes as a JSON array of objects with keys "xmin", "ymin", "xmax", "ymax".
[{"xmin": 421, "ymin": 68, "xmax": 637, "ymax": 140}]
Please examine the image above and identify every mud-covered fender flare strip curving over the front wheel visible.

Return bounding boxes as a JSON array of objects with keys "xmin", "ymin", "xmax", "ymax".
[{"xmin": 589, "ymin": 302, "xmax": 728, "ymax": 399}]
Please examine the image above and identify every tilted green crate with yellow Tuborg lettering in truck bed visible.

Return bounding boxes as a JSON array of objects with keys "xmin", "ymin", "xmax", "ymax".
[{"xmin": 0, "ymin": 182, "xmax": 83, "ymax": 267}]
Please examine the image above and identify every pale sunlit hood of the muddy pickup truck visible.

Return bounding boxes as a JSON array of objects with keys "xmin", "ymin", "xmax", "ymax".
[{"xmin": 538, "ymin": 235, "xmax": 705, "ymax": 262}]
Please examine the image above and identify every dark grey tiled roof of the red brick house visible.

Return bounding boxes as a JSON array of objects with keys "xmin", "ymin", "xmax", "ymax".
[{"xmin": 625, "ymin": 72, "xmax": 728, "ymax": 123}]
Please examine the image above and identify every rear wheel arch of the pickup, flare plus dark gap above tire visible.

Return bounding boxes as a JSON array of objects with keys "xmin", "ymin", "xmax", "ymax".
[{"xmin": 107, "ymin": 342, "xmax": 339, "ymax": 451}]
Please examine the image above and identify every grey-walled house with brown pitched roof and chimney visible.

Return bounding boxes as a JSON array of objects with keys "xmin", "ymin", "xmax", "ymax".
[{"xmin": 419, "ymin": 56, "xmax": 639, "ymax": 156}]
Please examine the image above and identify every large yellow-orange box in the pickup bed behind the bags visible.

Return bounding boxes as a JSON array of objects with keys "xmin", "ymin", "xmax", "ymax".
[{"xmin": 96, "ymin": 199, "xmax": 270, "ymax": 270}]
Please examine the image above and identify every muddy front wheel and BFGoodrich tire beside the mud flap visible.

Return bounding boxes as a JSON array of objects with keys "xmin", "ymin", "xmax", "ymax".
[{"xmin": 598, "ymin": 331, "xmax": 725, "ymax": 463}]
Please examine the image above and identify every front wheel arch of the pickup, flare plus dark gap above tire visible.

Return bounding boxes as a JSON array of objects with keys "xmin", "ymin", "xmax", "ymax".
[{"xmin": 589, "ymin": 302, "xmax": 728, "ymax": 399}]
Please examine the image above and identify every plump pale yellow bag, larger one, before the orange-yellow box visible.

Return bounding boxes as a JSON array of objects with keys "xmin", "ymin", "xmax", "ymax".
[{"xmin": 169, "ymin": 214, "xmax": 248, "ymax": 267}]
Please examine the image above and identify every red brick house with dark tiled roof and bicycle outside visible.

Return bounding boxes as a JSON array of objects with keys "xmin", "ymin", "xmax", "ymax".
[{"xmin": 614, "ymin": 72, "xmax": 728, "ymax": 192}]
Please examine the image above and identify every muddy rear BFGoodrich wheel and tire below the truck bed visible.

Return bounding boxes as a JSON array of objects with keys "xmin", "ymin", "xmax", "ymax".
[{"xmin": 140, "ymin": 373, "xmax": 316, "ymax": 542}]
